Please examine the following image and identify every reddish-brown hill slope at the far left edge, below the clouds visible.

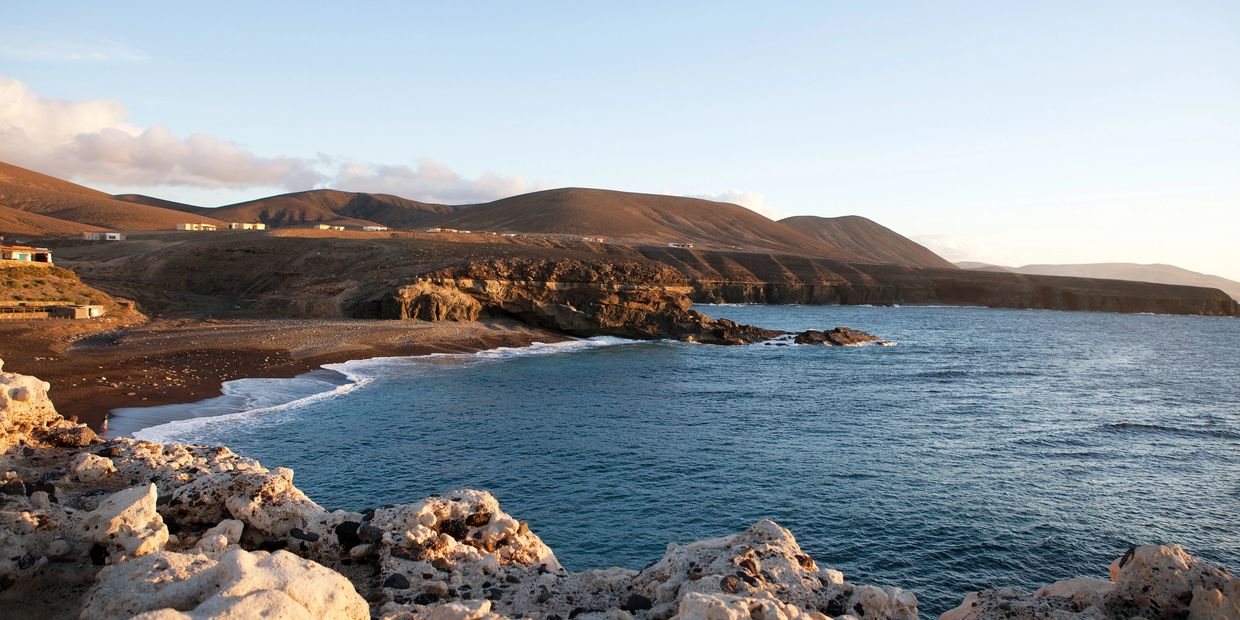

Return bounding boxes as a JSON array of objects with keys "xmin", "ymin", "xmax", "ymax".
[{"xmin": 0, "ymin": 162, "xmax": 221, "ymax": 234}]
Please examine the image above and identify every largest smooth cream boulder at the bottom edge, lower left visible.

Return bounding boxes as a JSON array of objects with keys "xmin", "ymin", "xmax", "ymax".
[{"xmin": 82, "ymin": 548, "xmax": 370, "ymax": 620}]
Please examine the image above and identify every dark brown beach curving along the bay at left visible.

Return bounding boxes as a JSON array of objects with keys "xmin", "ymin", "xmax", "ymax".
[{"xmin": 0, "ymin": 319, "xmax": 572, "ymax": 429}]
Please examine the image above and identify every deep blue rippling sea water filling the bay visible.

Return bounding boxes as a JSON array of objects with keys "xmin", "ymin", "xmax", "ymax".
[{"xmin": 119, "ymin": 306, "xmax": 1240, "ymax": 618}]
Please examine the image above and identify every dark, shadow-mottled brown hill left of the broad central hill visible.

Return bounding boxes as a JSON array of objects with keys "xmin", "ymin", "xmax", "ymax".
[{"xmin": 206, "ymin": 190, "xmax": 454, "ymax": 228}]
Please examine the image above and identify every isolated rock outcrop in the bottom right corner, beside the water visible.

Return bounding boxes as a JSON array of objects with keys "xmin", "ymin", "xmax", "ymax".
[{"xmin": 941, "ymin": 544, "xmax": 1240, "ymax": 620}]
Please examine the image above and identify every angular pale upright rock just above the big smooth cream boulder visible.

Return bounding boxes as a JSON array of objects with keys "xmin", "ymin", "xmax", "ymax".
[{"xmin": 82, "ymin": 485, "xmax": 167, "ymax": 556}]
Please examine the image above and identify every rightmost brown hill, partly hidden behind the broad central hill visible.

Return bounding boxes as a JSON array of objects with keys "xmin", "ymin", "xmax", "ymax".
[{"xmin": 780, "ymin": 216, "xmax": 956, "ymax": 269}]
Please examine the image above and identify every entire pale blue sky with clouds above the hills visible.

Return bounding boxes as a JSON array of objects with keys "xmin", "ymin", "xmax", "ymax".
[{"xmin": 0, "ymin": 0, "xmax": 1240, "ymax": 279}]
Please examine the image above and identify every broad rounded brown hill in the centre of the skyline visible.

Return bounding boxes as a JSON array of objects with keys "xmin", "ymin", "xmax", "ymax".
[{"xmin": 436, "ymin": 187, "xmax": 861, "ymax": 260}]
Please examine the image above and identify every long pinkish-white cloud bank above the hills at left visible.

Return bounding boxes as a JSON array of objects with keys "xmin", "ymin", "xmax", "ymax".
[{"xmin": 0, "ymin": 76, "xmax": 542, "ymax": 202}]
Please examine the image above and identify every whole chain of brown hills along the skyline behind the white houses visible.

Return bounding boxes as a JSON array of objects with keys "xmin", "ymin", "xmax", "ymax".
[{"xmin": 0, "ymin": 159, "xmax": 955, "ymax": 269}]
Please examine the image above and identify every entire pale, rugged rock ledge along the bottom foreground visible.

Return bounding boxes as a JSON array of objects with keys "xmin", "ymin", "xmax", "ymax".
[{"xmin": 0, "ymin": 359, "xmax": 1240, "ymax": 620}]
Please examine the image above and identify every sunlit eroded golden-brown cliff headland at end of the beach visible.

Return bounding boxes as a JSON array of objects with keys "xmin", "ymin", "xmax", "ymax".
[{"xmin": 351, "ymin": 260, "xmax": 782, "ymax": 345}]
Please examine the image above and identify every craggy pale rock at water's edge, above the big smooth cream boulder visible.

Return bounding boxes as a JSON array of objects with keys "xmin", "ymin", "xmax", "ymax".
[{"xmin": 165, "ymin": 467, "xmax": 325, "ymax": 539}]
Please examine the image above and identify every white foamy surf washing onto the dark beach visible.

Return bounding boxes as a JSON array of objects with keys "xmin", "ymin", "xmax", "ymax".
[{"xmin": 128, "ymin": 336, "xmax": 645, "ymax": 443}]
